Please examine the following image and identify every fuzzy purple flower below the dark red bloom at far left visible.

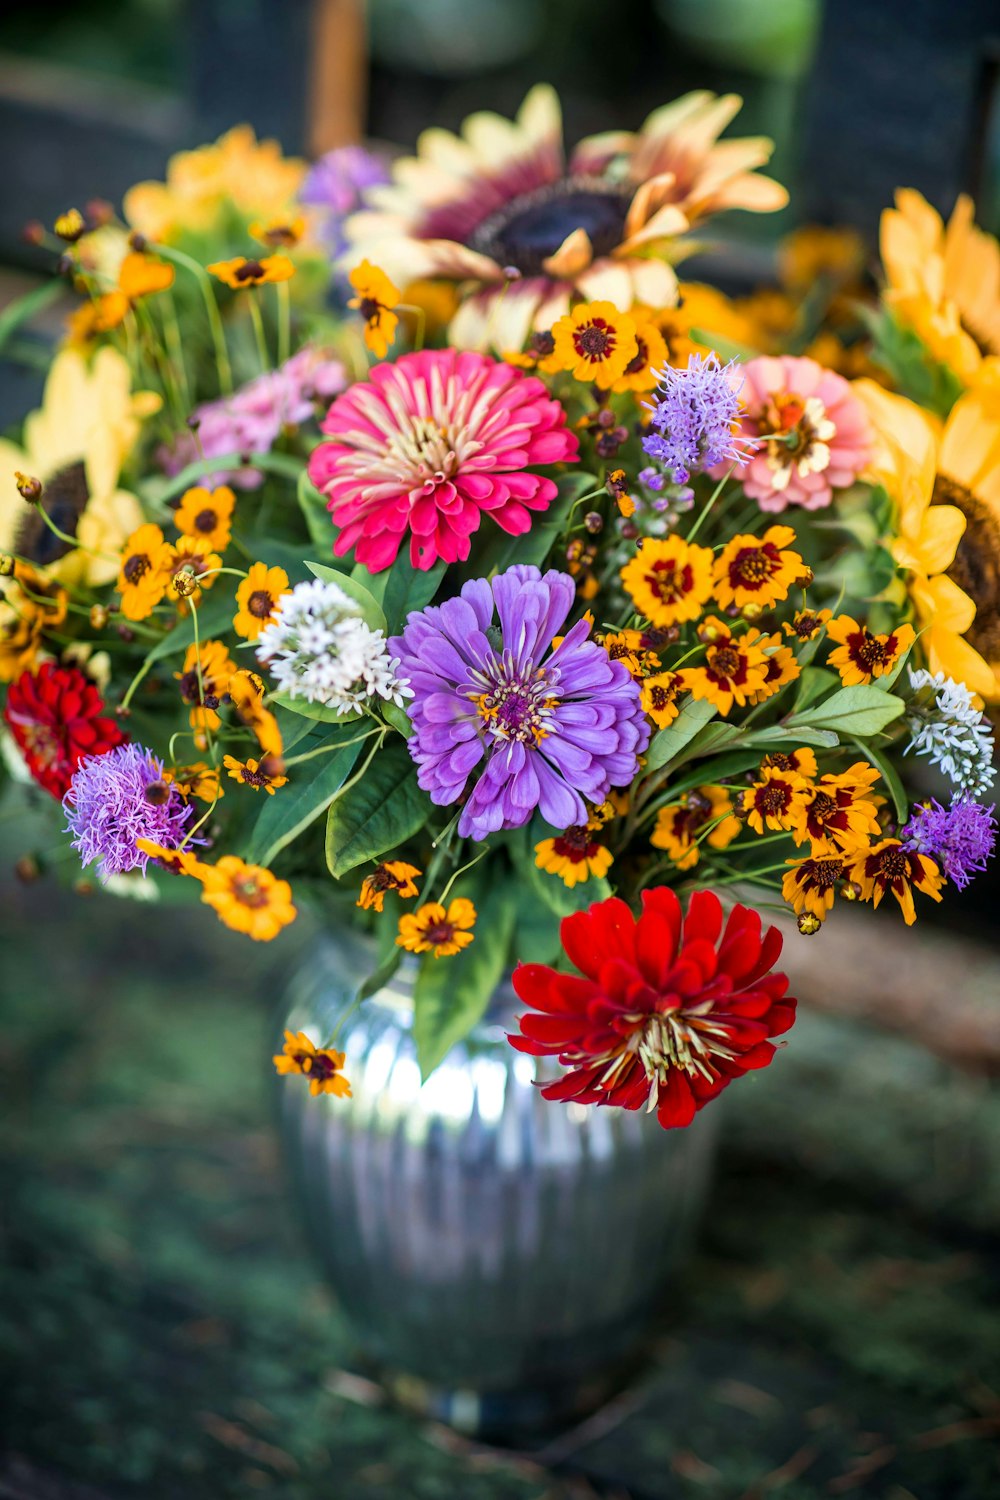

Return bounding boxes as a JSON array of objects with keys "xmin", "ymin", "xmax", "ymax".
[{"xmin": 63, "ymin": 744, "xmax": 202, "ymax": 881}]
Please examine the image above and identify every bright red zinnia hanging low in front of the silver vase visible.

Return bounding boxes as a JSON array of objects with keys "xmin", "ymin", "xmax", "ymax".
[{"xmin": 508, "ymin": 887, "xmax": 795, "ymax": 1128}]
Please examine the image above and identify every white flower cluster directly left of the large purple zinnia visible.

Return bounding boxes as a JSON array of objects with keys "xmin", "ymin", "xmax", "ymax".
[{"xmin": 256, "ymin": 579, "xmax": 414, "ymax": 714}]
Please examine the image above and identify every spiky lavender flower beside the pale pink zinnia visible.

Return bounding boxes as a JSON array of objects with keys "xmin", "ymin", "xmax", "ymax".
[{"xmin": 642, "ymin": 354, "xmax": 748, "ymax": 485}]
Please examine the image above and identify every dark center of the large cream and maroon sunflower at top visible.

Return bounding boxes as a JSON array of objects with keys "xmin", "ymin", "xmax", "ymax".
[{"xmin": 468, "ymin": 177, "xmax": 634, "ymax": 276}]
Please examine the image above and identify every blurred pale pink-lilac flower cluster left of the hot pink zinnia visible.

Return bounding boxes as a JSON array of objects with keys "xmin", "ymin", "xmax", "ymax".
[{"xmin": 159, "ymin": 345, "xmax": 346, "ymax": 489}]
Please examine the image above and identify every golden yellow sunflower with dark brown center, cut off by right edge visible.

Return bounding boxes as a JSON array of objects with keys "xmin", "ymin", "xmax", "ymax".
[{"xmin": 853, "ymin": 378, "xmax": 1000, "ymax": 701}]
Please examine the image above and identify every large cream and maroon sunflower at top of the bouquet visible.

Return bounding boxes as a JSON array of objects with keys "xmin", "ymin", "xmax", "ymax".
[{"xmin": 345, "ymin": 84, "xmax": 787, "ymax": 350}]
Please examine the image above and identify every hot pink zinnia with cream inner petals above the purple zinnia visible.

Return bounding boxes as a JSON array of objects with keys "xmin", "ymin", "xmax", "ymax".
[{"xmin": 309, "ymin": 350, "xmax": 579, "ymax": 573}]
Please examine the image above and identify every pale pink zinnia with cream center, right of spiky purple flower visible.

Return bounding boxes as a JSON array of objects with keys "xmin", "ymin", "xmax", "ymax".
[{"xmin": 718, "ymin": 354, "xmax": 873, "ymax": 510}]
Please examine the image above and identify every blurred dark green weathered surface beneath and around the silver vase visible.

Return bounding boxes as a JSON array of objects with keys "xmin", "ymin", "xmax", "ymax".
[{"xmin": 0, "ymin": 830, "xmax": 1000, "ymax": 1500}]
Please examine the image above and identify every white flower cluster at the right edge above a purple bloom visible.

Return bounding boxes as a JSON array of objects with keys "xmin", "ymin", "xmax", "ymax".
[{"xmin": 906, "ymin": 668, "xmax": 997, "ymax": 800}]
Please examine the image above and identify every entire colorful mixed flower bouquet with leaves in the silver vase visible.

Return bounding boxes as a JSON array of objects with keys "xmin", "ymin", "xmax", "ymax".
[{"xmin": 0, "ymin": 89, "xmax": 1000, "ymax": 1127}]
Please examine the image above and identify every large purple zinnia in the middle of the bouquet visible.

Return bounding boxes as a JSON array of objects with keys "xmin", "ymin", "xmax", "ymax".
[{"xmin": 390, "ymin": 566, "xmax": 649, "ymax": 839}]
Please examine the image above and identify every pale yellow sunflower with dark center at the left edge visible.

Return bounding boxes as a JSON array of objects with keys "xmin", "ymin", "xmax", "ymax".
[{"xmin": 0, "ymin": 348, "xmax": 160, "ymax": 587}]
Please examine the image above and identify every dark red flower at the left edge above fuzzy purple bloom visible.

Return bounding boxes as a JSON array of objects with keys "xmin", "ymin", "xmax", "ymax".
[{"xmin": 3, "ymin": 662, "xmax": 124, "ymax": 797}]
